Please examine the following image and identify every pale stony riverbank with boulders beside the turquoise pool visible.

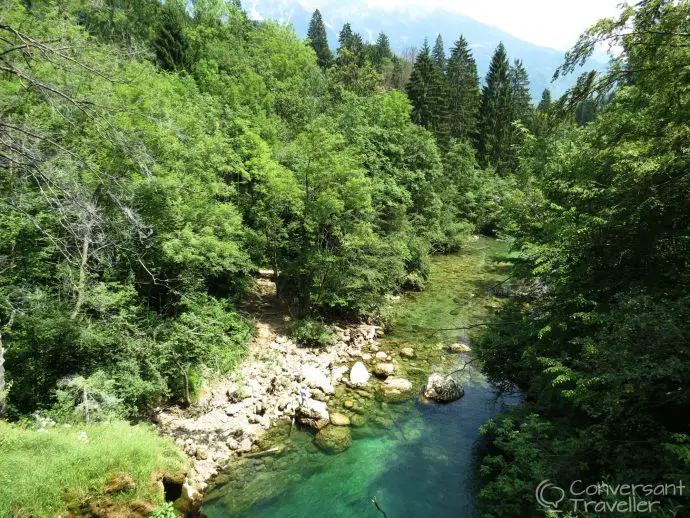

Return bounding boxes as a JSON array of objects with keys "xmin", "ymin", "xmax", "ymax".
[{"xmin": 156, "ymin": 325, "xmax": 424, "ymax": 508}]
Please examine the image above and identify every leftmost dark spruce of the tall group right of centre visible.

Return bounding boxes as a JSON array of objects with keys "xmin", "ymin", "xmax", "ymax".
[{"xmin": 407, "ymin": 40, "xmax": 450, "ymax": 143}]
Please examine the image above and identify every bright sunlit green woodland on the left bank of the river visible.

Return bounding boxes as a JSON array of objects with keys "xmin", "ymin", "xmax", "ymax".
[{"xmin": 0, "ymin": 0, "xmax": 528, "ymax": 422}]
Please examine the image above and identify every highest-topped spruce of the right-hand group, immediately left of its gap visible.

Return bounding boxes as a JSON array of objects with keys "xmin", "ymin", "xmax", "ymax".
[{"xmin": 446, "ymin": 36, "xmax": 481, "ymax": 140}]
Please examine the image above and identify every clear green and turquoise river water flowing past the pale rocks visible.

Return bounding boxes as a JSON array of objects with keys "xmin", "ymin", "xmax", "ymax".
[{"xmin": 204, "ymin": 240, "xmax": 517, "ymax": 518}]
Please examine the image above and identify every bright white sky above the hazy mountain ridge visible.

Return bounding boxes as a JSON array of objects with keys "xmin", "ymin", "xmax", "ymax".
[{"xmin": 301, "ymin": 0, "xmax": 622, "ymax": 50}]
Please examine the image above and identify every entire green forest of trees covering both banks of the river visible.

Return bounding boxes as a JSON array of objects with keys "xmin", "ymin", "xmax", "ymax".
[{"xmin": 0, "ymin": 0, "xmax": 690, "ymax": 517}]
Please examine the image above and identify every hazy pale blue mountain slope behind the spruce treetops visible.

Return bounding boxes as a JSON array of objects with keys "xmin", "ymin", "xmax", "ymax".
[{"xmin": 243, "ymin": 0, "xmax": 606, "ymax": 102}]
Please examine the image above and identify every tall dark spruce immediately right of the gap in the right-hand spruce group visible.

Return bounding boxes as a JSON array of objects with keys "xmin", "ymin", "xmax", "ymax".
[{"xmin": 478, "ymin": 43, "xmax": 513, "ymax": 174}]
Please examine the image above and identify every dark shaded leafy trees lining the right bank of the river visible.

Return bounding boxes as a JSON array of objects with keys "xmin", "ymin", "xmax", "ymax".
[{"xmin": 479, "ymin": 0, "xmax": 690, "ymax": 516}]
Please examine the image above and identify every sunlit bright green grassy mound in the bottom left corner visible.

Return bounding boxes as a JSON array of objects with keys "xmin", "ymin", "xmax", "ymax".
[{"xmin": 0, "ymin": 422, "xmax": 186, "ymax": 518}]
